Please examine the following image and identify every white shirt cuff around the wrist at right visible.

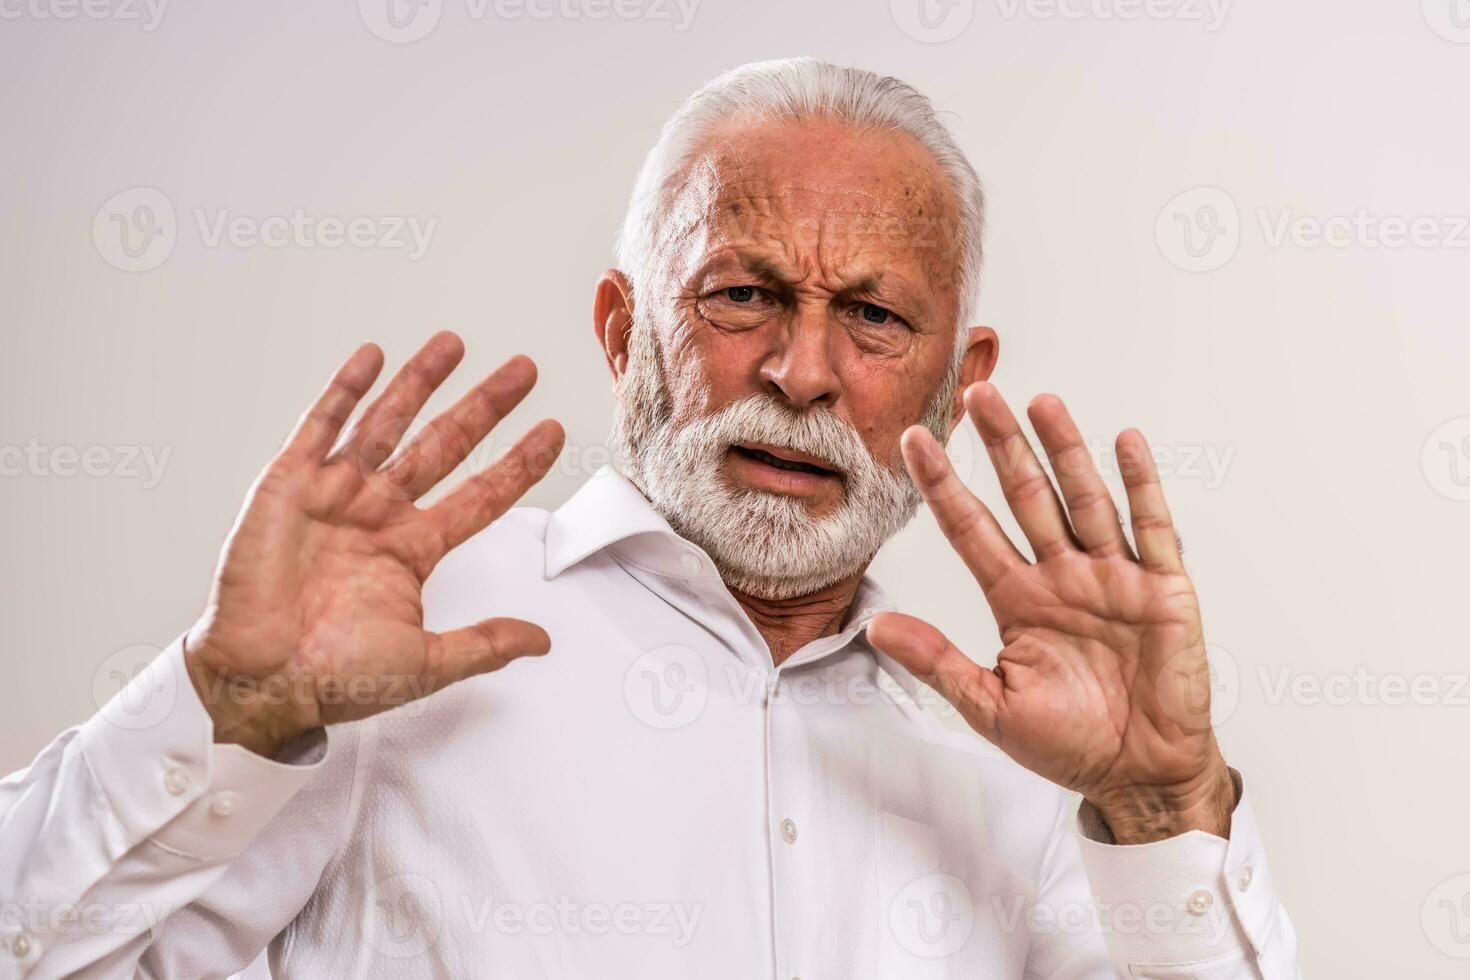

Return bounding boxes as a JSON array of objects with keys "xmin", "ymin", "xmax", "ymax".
[{"xmin": 1078, "ymin": 770, "xmax": 1277, "ymax": 967}]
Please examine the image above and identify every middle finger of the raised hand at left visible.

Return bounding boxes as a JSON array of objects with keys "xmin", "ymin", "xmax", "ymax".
[{"xmin": 375, "ymin": 354, "xmax": 537, "ymax": 500}]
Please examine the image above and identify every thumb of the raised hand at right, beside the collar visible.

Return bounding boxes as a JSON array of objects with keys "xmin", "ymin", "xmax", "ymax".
[{"xmin": 867, "ymin": 613, "xmax": 1005, "ymax": 742}]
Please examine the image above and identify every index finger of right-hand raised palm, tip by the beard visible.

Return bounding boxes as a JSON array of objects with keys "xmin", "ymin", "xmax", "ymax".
[{"xmin": 900, "ymin": 426, "xmax": 1026, "ymax": 591}]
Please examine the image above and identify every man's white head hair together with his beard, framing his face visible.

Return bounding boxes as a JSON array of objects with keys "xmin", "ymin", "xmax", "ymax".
[{"xmin": 610, "ymin": 57, "xmax": 985, "ymax": 599}]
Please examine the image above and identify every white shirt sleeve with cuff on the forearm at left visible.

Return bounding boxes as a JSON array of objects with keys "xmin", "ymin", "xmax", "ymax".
[{"xmin": 0, "ymin": 642, "xmax": 353, "ymax": 980}]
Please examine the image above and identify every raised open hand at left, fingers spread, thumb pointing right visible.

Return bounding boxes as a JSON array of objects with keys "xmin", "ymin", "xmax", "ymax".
[{"xmin": 185, "ymin": 332, "xmax": 563, "ymax": 755}]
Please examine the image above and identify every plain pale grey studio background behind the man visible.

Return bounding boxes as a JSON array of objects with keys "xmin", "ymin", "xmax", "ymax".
[{"xmin": 0, "ymin": 0, "xmax": 1470, "ymax": 977}]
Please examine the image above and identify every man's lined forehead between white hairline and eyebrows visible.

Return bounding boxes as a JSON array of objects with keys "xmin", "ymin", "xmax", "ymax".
[{"xmin": 666, "ymin": 120, "xmax": 958, "ymax": 253}]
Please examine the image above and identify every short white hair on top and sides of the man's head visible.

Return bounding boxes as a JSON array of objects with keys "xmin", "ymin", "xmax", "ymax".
[{"xmin": 617, "ymin": 57, "xmax": 985, "ymax": 331}]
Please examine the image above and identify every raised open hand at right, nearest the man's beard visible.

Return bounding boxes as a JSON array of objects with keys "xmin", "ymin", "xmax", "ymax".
[{"xmin": 869, "ymin": 383, "xmax": 1235, "ymax": 843}]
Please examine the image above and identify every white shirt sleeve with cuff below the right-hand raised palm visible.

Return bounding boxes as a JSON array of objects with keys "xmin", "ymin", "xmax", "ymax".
[{"xmin": 1026, "ymin": 777, "xmax": 1301, "ymax": 980}]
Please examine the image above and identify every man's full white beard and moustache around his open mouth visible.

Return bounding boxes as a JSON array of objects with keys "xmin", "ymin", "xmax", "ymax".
[{"xmin": 610, "ymin": 323, "xmax": 960, "ymax": 599}]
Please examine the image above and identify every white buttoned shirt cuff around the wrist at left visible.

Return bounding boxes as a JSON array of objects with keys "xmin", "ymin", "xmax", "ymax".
[{"xmin": 78, "ymin": 638, "xmax": 328, "ymax": 860}]
